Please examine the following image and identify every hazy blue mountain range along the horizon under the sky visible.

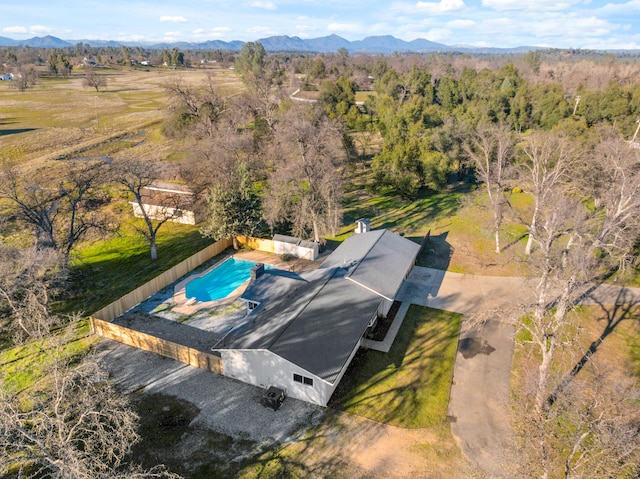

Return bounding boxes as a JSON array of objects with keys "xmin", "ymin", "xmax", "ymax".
[{"xmin": 0, "ymin": 35, "xmax": 539, "ymax": 54}]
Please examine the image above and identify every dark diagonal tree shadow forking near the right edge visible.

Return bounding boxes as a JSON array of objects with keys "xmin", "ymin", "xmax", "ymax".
[{"xmin": 547, "ymin": 288, "xmax": 640, "ymax": 406}]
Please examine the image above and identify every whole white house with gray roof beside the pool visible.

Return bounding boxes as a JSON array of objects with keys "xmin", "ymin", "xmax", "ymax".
[{"xmin": 212, "ymin": 230, "xmax": 420, "ymax": 406}]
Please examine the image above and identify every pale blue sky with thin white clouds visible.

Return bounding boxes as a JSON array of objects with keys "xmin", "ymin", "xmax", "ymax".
[{"xmin": 0, "ymin": 0, "xmax": 640, "ymax": 49}]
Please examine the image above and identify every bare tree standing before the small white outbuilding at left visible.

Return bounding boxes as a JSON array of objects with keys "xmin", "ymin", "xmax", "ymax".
[{"xmin": 112, "ymin": 158, "xmax": 184, "ymax": 260}]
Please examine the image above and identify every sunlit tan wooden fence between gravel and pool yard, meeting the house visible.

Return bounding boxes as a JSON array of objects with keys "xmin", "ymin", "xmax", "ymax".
[{"xmin": 89, "ymin": 317, "xmax": 223, "ymax": 374}]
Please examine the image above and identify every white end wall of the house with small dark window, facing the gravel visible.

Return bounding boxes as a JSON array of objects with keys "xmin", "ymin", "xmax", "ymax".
[{"xmin": 219, "ymin": 349, "xmax": 337, "ymax": 406}]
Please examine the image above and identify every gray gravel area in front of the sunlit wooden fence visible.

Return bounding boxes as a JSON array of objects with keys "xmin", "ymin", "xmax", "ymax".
[{"xmin": 98, "ymin": 339, "xmax": 324, "ymax": 444}]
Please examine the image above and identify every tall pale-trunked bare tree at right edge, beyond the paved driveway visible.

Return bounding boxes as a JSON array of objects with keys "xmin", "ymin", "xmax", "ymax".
[{"xmin": 521, "ymin": 132, "xmax": 640, "ymax": 416}]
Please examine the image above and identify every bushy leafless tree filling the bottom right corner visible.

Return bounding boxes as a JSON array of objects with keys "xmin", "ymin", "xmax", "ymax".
[{"xmin": 514, "ymin": 360, "xmax": 640, "ymax": 479}]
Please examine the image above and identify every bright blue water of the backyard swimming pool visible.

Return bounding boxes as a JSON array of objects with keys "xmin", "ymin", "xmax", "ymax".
[{"xmin": 185, "ymin": 258, "xmax": 270, "ymax": 301}]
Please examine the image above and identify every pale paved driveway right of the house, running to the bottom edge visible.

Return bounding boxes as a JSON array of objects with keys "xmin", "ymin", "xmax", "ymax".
[{"xmin": 400, "ymin": 267, "xmax": 640, "ymax": 478}]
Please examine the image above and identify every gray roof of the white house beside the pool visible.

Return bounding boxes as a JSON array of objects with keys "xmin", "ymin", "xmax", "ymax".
[{"xmin": 214, "ymin": 230, "xmax": 419, "ymax": 383}]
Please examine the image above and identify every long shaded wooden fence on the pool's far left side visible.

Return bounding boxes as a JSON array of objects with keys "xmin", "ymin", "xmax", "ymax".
[{"xmin": 93, "ymin": 239, "xmax": 233, "ymax": 321}]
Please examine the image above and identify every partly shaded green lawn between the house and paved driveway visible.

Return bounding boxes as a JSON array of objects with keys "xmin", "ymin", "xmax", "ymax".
[{"xmin": 335, "ymin": 305, "xmax": 461, "ymax": 428}]
